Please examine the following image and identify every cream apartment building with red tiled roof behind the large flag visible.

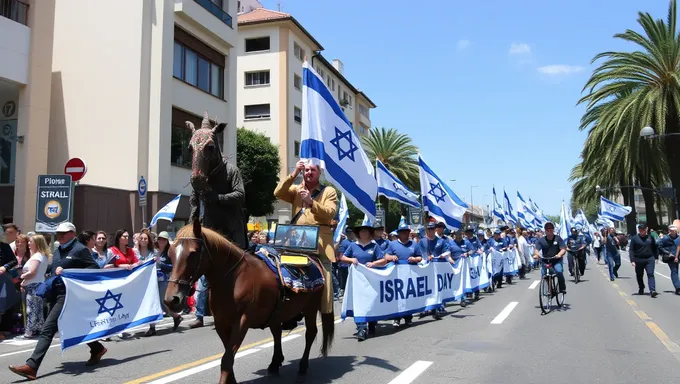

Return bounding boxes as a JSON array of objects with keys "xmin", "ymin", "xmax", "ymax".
[{"xmin": 236, "ymin": 0, "xmax": 376, "ymax": 222}]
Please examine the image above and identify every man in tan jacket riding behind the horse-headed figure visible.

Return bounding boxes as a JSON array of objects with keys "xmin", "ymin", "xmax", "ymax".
[{"xmin": 274, "ymin": 161, "xmax": 338, "ymax": 313}]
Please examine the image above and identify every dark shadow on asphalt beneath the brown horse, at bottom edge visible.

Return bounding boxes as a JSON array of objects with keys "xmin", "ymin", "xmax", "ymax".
[{"xmin": 243, "ymin": 356, "xmax": 399, "ymax": 384}]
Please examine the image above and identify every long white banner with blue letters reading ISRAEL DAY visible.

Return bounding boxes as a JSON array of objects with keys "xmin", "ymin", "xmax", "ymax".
[{"xmin": 342, "ymin": 257, "xmax": 470, "ymax": 322}]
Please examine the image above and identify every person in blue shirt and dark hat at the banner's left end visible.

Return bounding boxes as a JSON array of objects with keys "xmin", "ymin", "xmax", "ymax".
[{"xmin": 340, "ymin": 225, "xmax": 383, "ymax": 341}]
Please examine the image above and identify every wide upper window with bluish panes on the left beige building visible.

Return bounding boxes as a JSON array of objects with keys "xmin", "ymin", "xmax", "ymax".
[{"xmin": 172, "ymin": 41, "xmax": 224, "ymax": 99}]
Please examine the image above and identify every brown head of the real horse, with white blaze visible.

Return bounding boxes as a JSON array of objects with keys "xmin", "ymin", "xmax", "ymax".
[{"xmin": 163, "ymin": 220, "xmax": 209, "ymax": 312}]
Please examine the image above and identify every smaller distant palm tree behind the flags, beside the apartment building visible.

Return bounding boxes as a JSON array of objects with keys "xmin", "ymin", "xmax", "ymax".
[{"xmin": 361, "ymin": 127, "xmax": 420, "ymax": 228}]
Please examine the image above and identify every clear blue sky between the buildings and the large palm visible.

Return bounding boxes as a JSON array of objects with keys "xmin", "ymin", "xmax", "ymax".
[{"xmin": 262, "ymin": 0, "xmax": 668, "ymax": 215}]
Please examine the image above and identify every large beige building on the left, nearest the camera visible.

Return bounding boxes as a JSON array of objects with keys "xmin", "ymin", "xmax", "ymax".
[{"xmin": 0, "ymin": 0, "xmax": 238, "ymax": 237}]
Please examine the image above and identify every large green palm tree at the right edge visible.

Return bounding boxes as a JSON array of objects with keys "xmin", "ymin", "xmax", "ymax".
[{"xmin": 579, "ymin": 0, "xmax": 680, "ymax": 220}]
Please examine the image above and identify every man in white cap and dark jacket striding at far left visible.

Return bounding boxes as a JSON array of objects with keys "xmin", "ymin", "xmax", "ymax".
[{"xmin": 9, "ymin": 222, "xmax": 107, "ymax": 380}]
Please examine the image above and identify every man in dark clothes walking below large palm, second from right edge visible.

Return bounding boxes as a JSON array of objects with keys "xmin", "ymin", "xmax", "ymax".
[{"xmin": 630, "ymin": 223, "xmax": 659, "ymax": 297}]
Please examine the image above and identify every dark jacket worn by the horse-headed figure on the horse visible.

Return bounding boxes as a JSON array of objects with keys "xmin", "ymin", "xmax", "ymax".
[{"xmin": 189, "ymin": 158, "xmax": 248, "ymax": 249}]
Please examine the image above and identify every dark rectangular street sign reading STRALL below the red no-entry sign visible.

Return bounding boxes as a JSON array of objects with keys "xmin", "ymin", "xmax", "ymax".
[{"xmin": 35, "ymin": 175, "xmax": 73, "ymax": 233}]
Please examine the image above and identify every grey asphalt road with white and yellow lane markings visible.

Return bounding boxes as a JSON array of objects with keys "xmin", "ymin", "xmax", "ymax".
[{"xmin": 0, "ymin": 253, "xmax": 680, "ymax": 384}]
